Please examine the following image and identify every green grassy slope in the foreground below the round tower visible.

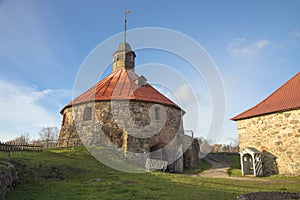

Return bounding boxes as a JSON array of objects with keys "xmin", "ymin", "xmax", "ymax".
[{"xmin": 7, "ymin": 148, "xmax": 300, "ymax": 200}]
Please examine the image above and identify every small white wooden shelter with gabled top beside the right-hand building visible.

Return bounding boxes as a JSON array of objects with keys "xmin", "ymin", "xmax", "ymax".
[{"xmin": 240, "ymin": 147, "xmax": 263, "ymax": 176}]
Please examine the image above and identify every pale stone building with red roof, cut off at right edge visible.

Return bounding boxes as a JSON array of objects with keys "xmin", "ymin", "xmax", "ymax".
[{"xmin": 232, "ymin": 73, "xmax": 300, "ymax": 176}]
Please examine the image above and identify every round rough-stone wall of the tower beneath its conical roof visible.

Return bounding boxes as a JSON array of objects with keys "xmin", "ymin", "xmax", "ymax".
[{"xmin": 59, "ymin": 100, "xmax": 189, "ymax": 172}]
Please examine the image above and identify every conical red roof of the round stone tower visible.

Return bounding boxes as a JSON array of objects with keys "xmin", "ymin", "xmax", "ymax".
[{"xmin": 61, "ymin": 68, "xmax": 180, "ymax": 113}]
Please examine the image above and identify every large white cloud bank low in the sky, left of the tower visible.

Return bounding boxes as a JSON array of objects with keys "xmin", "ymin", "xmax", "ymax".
[{"xmin": 0, "ymin": 79, "xmax": 70, "ymax": 141}]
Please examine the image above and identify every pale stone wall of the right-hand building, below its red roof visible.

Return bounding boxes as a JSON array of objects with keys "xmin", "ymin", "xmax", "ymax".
[{"xmin": 237, "ymin": 109, "xmax": 300, "ymax": 176}]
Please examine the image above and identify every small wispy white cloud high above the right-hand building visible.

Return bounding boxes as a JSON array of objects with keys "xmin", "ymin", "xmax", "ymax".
[{"xmin": 226, "ymin": 38, "xmax": 270, "ymax": 57}]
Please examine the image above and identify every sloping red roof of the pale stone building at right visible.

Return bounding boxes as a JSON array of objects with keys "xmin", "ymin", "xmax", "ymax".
[{"xmin": 231, "ymin": 72, "xmax": 300, "ymax": 121}]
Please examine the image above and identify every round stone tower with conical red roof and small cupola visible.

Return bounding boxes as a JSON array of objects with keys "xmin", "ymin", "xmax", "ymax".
[{"xmin": 58, "ymin": 43, "xmax": 199, "ymax": 172}]
